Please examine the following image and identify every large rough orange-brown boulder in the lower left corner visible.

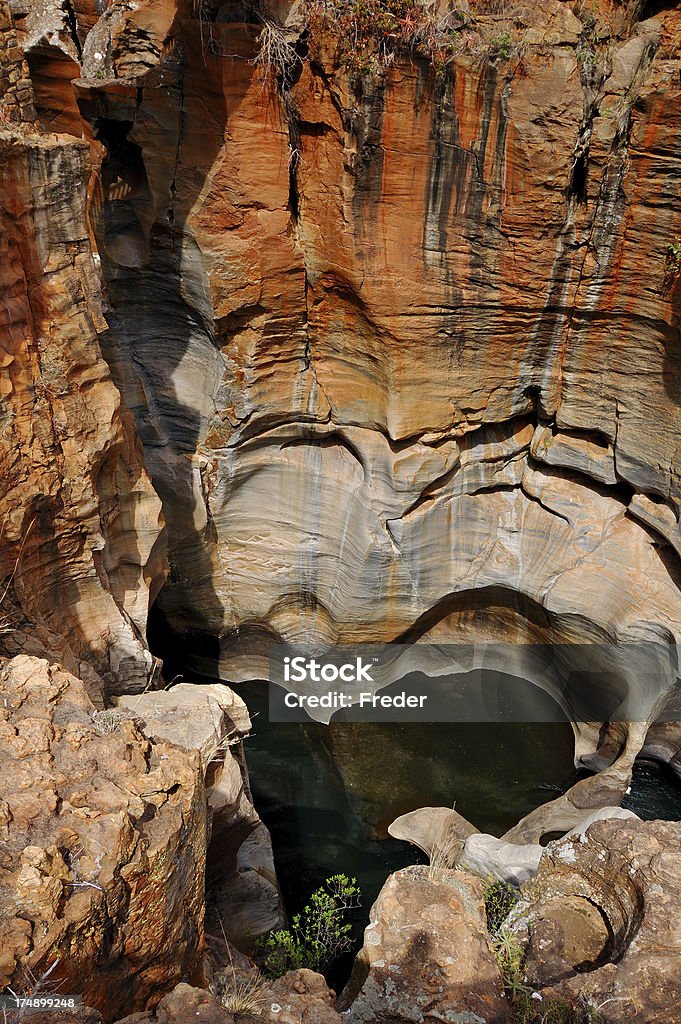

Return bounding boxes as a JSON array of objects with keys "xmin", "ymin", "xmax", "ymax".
[{"xmin": 0, "ymin": 657, "xmax": 206, "ymax": 1020}]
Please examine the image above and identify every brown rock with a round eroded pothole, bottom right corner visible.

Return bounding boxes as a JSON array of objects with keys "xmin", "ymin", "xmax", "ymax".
[{"xmin": 510, "ymin": 821, "xmax": 681, "ymax": 1024}]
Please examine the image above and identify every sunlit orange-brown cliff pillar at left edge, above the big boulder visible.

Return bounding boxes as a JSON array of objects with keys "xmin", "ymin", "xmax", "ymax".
[{"xmin": 0, "ymin": 129, "xmax": 166, "ymax": 689}]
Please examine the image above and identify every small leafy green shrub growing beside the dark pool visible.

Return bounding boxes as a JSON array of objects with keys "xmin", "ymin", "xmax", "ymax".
[{"xmin": 256, "ymin": 874, "xmax": 360, "ymax": 978}]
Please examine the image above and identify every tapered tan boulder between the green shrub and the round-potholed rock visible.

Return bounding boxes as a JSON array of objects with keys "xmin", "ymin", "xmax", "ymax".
[{"xmin": 339, "ymin": 867, "xmax": 508, "ymax": 1024}]
